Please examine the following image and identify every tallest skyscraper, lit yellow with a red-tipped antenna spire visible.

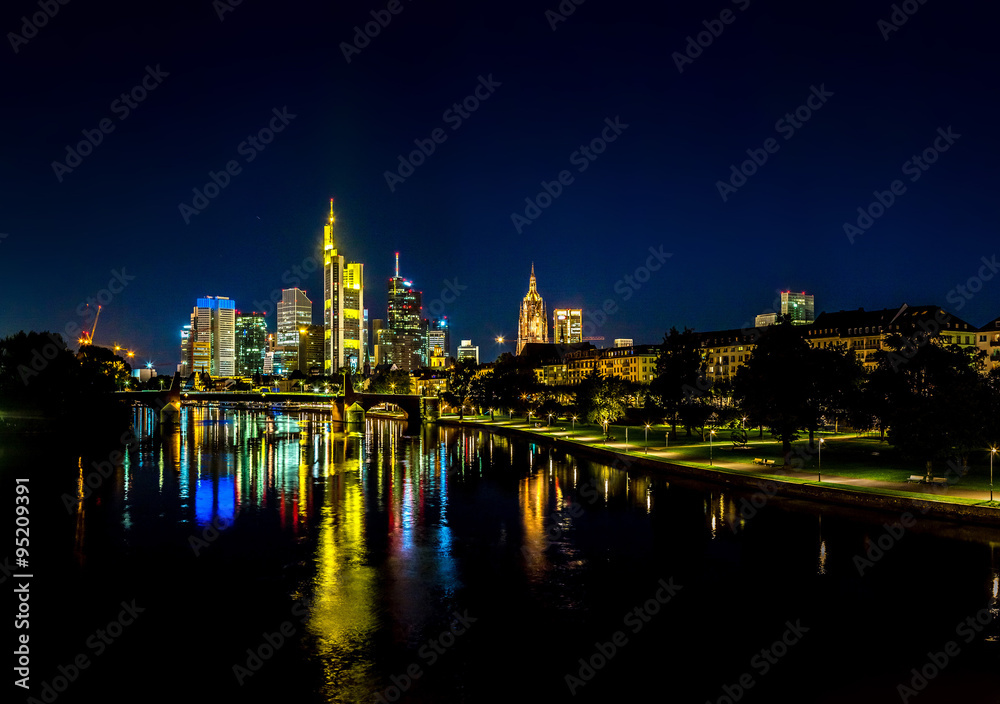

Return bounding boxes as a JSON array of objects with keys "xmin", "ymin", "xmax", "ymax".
[{"xmin": 323, "ymin": 198, "xmax": 367, "ymax": 374}]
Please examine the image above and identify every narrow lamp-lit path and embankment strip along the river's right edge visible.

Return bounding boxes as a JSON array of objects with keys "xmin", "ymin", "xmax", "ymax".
[{"xmin": 438, "ymin": 416, "xmax": 1000, "ymax": 526}]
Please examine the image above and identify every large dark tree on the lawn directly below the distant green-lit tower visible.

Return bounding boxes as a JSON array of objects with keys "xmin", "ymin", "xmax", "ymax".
[{"xmin": 733, "ymin": 316, "xmax": 817, "ymax": 466}]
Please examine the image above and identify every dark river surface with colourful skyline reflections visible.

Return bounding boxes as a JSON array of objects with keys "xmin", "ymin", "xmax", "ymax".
[{"xmin": 7, "ymin": 408, "xmax": 1000, "ymax": 704}]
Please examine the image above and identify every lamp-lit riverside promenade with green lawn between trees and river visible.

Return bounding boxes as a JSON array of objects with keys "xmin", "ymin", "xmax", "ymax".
[{"xmin": 438, "ymin": 415, "xmax": 1000, "ymax": 526}]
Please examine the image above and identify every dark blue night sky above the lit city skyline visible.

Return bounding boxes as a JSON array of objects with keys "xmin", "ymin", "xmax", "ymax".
[{"xmin": 0, "ymin": 0, "xmax": 1000, "ymax": 373}]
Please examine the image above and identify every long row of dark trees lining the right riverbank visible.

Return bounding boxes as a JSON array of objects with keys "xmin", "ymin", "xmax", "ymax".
[{"xmin": 446, "ymin": 319, "xmax": 1000, "ymax": 471}]
